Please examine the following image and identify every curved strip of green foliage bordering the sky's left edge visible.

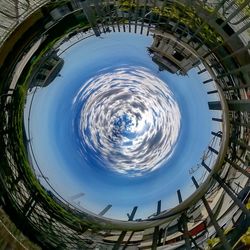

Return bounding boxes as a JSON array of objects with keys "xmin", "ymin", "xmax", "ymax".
[{"xmin": 1, "ymin": 20, "xmax": 99, "ymax": 240}]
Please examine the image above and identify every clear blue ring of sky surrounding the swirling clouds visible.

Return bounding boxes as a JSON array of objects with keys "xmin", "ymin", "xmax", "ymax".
[{"xmin": 25, "ymin": 30, "xmax": 213, "ymax": 220}]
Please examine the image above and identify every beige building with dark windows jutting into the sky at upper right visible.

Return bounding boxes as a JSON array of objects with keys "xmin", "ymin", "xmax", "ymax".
[{"xmin": 149, "ymin": 30, "xmax": 197, "ymax": 75}]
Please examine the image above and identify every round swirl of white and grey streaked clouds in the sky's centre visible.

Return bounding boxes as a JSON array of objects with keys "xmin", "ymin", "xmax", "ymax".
[{"xmin": 73, "ymin": 66, "xmax": 181, "ymax": 177}]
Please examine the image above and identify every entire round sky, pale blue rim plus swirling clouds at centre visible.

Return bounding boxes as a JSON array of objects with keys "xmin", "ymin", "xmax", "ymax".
[{"xmin": 24, "ymin": 29, "xmax": 220, "ymax": 220}]
